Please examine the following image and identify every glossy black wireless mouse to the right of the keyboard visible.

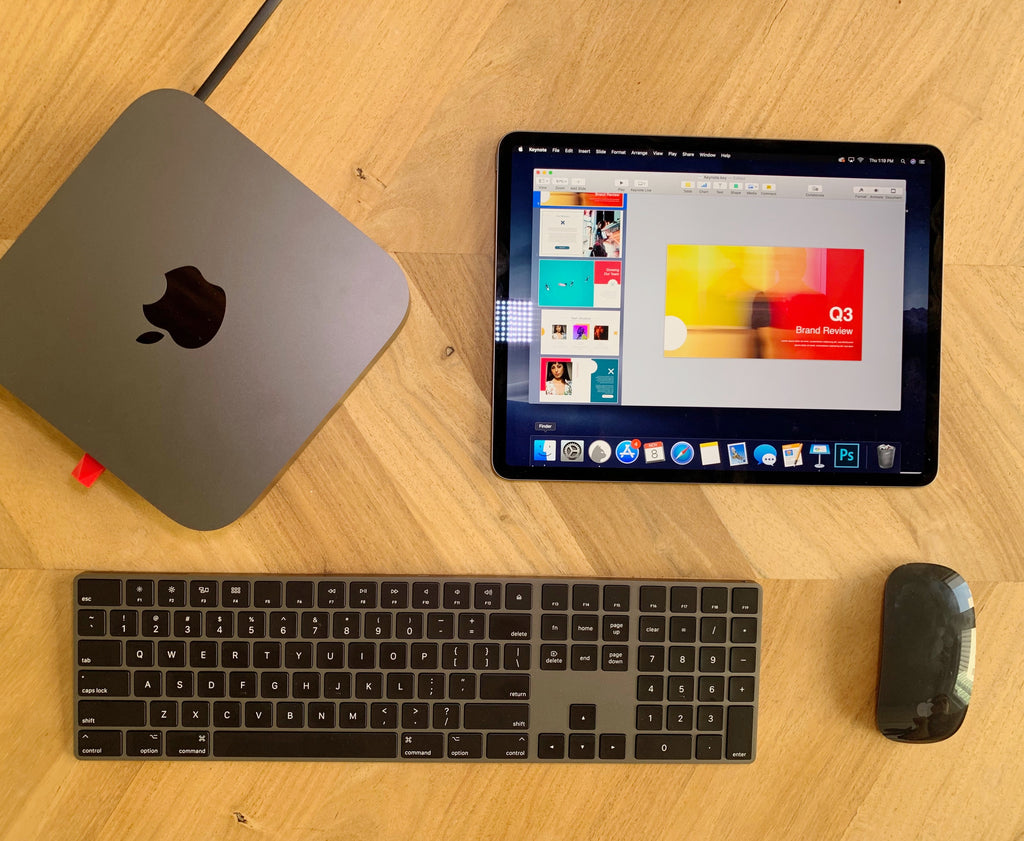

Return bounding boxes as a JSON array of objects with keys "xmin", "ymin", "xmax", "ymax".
[{"xmin": 876, "ymin": 563, "xmax": 975, "ymax": 742}]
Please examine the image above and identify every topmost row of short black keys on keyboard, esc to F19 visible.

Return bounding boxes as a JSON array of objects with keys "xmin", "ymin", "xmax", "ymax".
[{"xmin": 77, "ymin": 578, "xmax": 759, "ymax": 615}]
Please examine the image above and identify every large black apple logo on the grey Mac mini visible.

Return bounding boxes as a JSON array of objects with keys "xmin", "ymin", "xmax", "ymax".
[{"xmin": 135, "ymin": 265, "xmax": 227, "ymax": 348}]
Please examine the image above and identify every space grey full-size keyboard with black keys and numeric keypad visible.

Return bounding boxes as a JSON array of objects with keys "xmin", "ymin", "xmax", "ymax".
[{"xmin": 74, "ymin": 573, "xmax": 761, "ymax": 763}]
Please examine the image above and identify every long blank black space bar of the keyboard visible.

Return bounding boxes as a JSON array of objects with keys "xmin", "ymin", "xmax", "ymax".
[{"xmin": 213, "ymin": 730, "xmax": 398, "ymax": 759}]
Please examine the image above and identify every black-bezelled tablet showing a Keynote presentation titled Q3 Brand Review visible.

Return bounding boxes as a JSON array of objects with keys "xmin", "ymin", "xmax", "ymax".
[{"xmin": 493, "ymin": 132, "xmax": 945, "ymax": 486}]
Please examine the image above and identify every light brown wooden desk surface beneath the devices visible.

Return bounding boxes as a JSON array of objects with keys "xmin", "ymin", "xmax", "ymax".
[{"xmin": 0, "ymin": 0, "xmax": 1024, "ymax": 841}]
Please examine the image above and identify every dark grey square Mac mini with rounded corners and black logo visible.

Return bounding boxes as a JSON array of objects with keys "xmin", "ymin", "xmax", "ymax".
[{"xmin": 0, "ymin": 90, "xmax": 409, "ymax": 530}]
